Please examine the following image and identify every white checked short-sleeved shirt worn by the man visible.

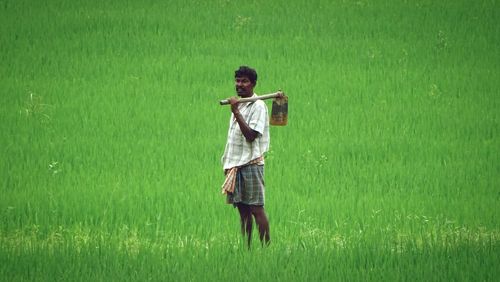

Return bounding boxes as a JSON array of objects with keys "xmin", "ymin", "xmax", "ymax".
[{"xmin": 221, "ymin": 94, "xmax": 269, "ymax": 169}]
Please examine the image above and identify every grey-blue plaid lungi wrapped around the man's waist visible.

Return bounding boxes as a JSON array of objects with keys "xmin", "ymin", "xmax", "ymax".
[{"xmin": 227, "ymin": 164, "xmax": 265, "ymax": 206}]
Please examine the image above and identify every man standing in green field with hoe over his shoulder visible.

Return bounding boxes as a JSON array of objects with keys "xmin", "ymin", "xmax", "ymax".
[{"xmin": 222, "ymin": 66, "xmax": 270, "ymax": 247}]
